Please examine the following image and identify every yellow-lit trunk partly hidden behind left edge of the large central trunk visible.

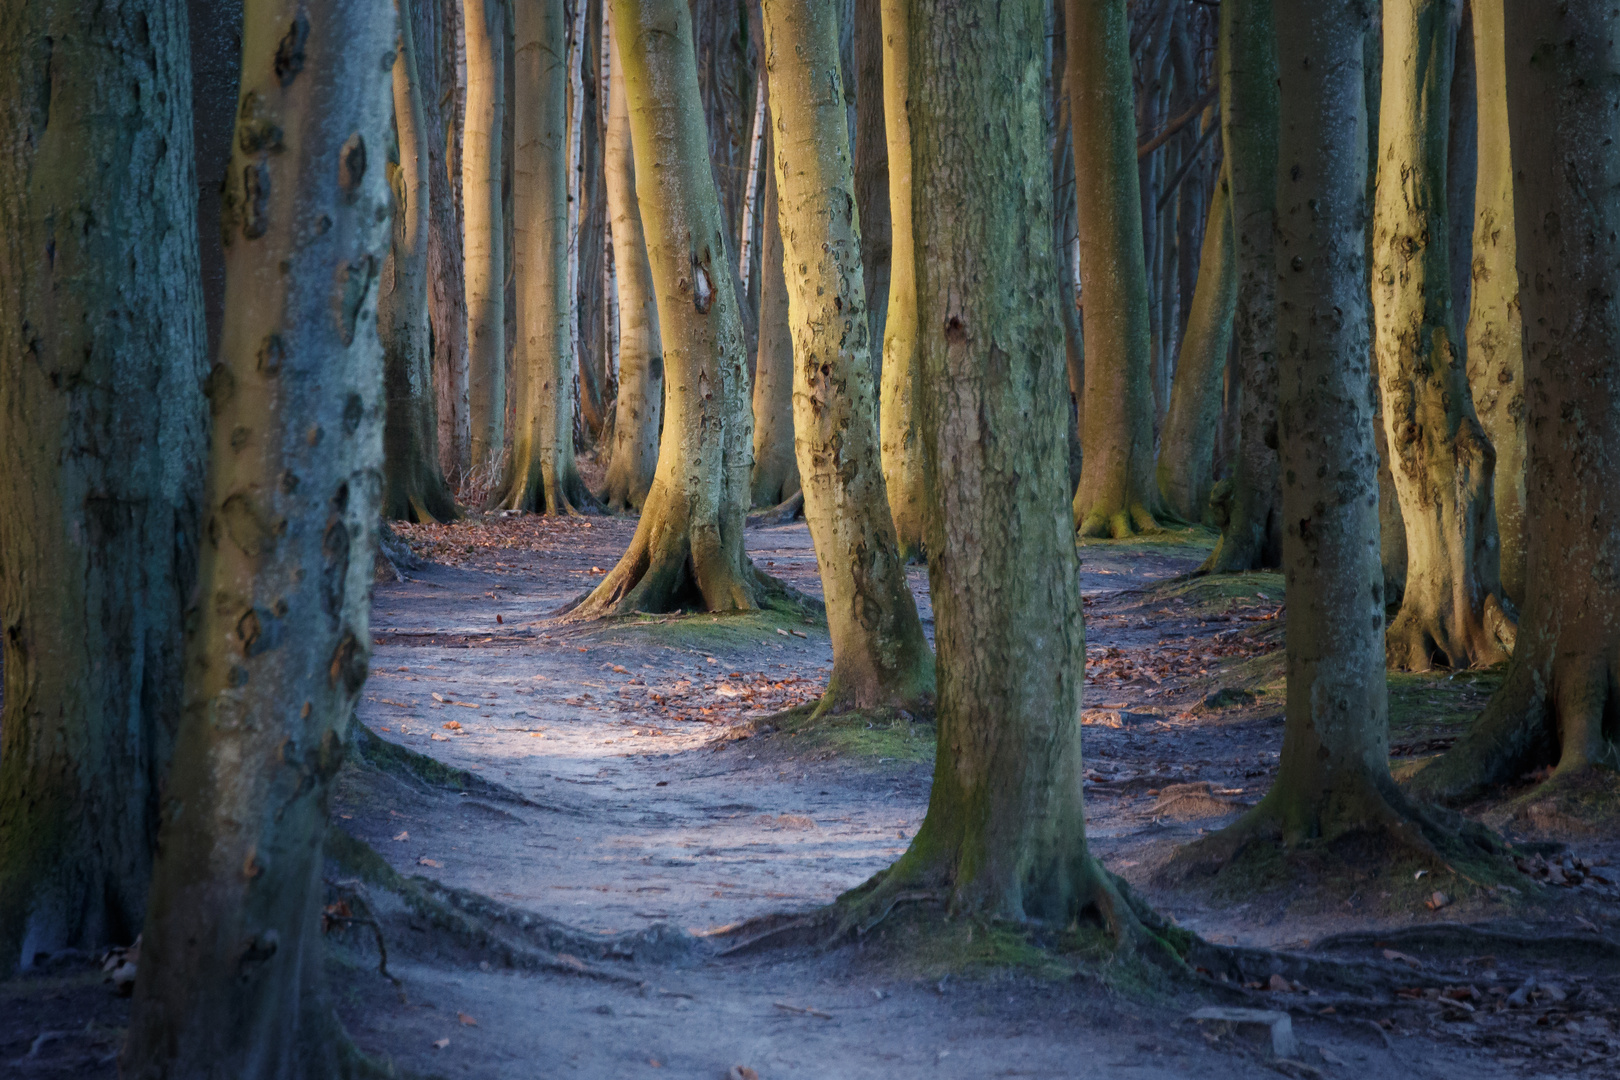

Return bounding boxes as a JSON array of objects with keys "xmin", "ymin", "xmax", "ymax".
[{"xmin": 878, "ymin": 0, "xmax": 927, "ymax": 560}]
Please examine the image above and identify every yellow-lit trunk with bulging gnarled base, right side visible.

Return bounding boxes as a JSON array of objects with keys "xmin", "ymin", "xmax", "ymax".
[{"xmin": 1372, "ymin": 0, "xmax": 1511, "ymax": 670}]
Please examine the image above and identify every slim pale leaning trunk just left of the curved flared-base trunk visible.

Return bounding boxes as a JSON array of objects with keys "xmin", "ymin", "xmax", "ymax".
[{"xmin": 601, "ymin": 15, "xmax": 664, "ymax": 510}]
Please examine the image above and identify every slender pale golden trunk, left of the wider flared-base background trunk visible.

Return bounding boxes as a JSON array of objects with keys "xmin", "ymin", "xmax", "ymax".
[{"xmin": 462, "ymin": 0, "xmax": 507, "ymax": 471}]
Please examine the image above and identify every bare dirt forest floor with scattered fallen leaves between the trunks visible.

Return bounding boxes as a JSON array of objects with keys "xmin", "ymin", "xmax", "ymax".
[{"xmin": 0, "ymin": 515, "xmax": 1620, "ymax": 1080}]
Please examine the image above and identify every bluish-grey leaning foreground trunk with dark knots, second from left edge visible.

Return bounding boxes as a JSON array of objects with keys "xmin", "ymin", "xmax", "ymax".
[{"xmin": 123, "ymin": 0, "xmax": 395, "ymax": 1080}]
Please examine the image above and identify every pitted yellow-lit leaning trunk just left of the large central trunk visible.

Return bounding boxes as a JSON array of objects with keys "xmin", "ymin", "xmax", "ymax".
[{"xmin": 763, "ymin": 0, "xmax": 933, "ymax": 712}]
